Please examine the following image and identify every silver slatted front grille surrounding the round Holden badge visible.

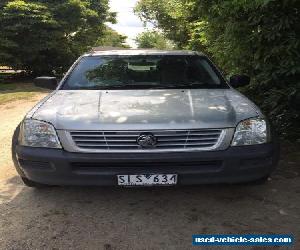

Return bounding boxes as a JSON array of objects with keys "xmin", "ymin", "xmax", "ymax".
[{"xmin": 70, "ymin": 129, "xmax": 224, "ymax": 151}]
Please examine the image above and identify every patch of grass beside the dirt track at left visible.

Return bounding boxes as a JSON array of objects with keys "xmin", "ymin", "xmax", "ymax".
[{"xmin": 0, "ymin": 82, "xmax": 48, "ymax": 105}]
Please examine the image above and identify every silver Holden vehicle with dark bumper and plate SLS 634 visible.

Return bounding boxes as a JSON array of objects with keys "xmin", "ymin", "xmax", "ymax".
[{"xmin": 12, "ymin": 50, "xmax": 279, "ymax": 187}]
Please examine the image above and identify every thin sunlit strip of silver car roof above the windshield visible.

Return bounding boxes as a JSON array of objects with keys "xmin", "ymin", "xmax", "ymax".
[{"xmin": 84, "ymin": 49, "xmax": 204, "ymax": 56}]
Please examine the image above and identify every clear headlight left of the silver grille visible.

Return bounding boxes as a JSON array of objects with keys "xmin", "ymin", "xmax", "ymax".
[{"xmin": 19, "ymin": 119, "xmax": 61, "ymax": 148}]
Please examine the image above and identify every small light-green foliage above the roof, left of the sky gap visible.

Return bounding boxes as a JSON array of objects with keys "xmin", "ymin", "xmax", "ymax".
[{"xmin": 95, "ymin": 26, "xmax": 129, "ymax": 48}]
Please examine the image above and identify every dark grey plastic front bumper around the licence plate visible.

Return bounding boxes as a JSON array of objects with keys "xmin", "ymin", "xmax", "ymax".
[{"xmin": 15, "ymin": 144, "xmax": 279, "ymax": 186}]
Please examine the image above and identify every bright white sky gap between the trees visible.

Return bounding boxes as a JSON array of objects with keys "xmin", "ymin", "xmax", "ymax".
[{"xmin": 109, "ymin": 0, "xmax": 151, "ymax": 48}]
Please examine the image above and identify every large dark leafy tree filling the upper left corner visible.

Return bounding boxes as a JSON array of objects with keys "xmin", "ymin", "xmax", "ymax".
[{"xmin": 0, "ymin": 0, "xmax": 115, "ymax": 74}]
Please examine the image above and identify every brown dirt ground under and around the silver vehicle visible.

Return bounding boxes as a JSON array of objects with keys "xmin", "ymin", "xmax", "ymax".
[{"xmin": 0, "ymin": 94, "xmax": 300, "ymax": 250}]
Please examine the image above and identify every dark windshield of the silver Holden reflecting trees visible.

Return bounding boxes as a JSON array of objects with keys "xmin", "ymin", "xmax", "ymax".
[{"xmin": 62, "ymin": 55, "xmax": 228, "ymax": 90}]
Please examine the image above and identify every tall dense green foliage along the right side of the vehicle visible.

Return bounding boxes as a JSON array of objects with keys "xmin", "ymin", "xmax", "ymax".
[{"xmin": 135, "ymin": 0, "xmax": 300, "ymax": 139}]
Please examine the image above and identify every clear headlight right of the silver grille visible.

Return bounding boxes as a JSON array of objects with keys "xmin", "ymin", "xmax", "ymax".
[{"xmin": 231, "ymin": 118, "xmax": 269, "ymax": 146}]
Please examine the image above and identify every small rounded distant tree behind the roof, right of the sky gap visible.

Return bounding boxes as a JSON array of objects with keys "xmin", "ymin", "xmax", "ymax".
[{"xmin": 135, "ymin": 31, "xmax": 175, "ymax": 49}]
